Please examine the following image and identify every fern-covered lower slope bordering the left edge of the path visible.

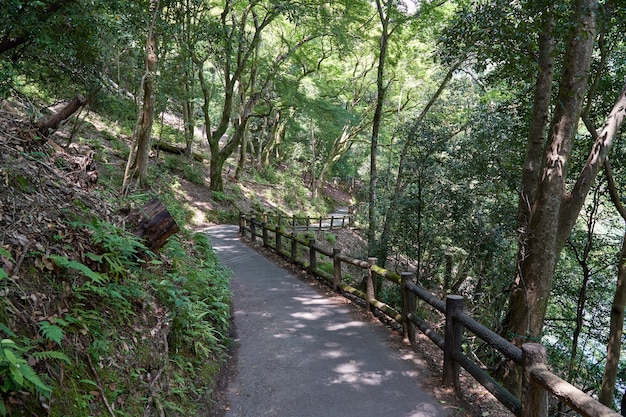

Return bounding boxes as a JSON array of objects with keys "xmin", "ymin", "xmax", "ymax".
[{"xmin": 0, "ymin": 219, "xmax": 230, "ymax": 417}]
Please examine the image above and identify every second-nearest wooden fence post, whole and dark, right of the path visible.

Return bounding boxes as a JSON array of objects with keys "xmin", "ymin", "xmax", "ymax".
[{"xmin": 443, "ymin": 295, "xmax": 463, "ymax": 389}]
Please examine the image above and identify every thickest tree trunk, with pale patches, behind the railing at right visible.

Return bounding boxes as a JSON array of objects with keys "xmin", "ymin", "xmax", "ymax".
[{"xmin": 503, "ymin": 0, "xmax": 597, "ymax": 395}]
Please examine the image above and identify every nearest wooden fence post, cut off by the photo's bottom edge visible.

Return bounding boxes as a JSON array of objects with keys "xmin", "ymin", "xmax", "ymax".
[{"xmin": 521, "ymin": 343, "xmax": 548, "ymax": 417}]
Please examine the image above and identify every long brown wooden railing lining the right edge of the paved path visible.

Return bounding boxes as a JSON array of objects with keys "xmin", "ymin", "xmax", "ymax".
[{"xmin": 239, "ymin": 214, "xmax": 620, "ymax": 417}]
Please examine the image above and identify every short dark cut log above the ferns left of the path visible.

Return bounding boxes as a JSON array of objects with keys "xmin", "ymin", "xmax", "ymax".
[{"xmin": 129, "ymin": 198, "xmax": 180, "ymax": 252}]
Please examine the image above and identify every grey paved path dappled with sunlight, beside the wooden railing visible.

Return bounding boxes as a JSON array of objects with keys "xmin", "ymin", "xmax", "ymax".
[{"xmin": 207, "ymin": 225, "xmax": 452, "ymax": 417}]
